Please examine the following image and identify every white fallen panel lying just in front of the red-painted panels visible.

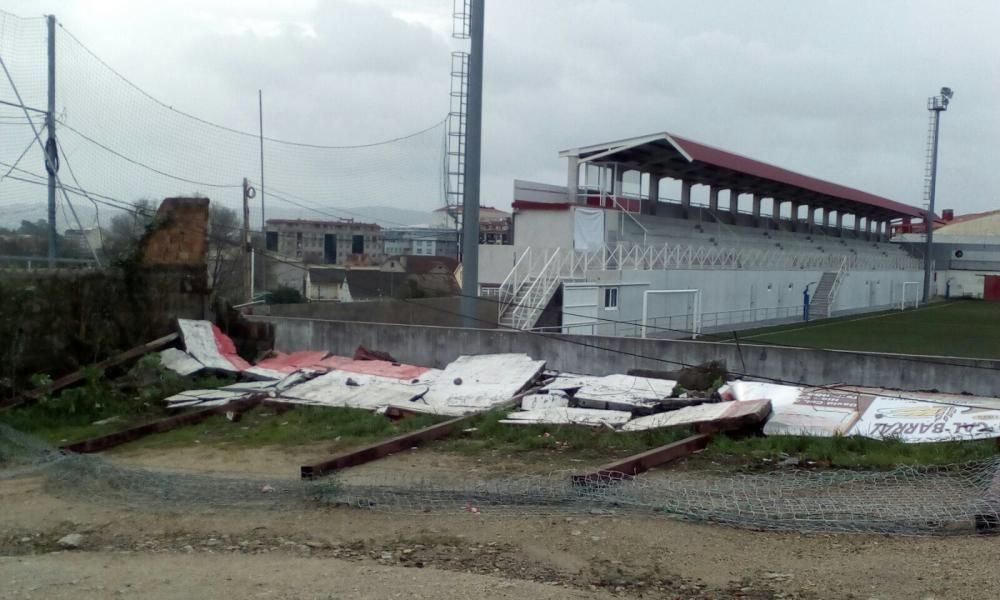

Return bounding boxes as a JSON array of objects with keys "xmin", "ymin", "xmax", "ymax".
[{"xmin": 280, "ymin": 371, "xmax": 428, "ymax": 410}]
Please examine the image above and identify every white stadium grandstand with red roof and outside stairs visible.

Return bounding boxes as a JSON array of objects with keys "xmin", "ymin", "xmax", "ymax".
[{"xmin": 480, "ymin": 133, "xmax": 924, "ymax": 337}]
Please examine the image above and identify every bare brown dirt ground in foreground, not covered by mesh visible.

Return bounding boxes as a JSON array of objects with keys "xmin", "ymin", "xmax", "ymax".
[{"xmin": 0, "ymin": 447, "xmax": 1000, "ymax": 600}]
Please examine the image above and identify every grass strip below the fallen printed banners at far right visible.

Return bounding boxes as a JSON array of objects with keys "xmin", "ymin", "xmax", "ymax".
[{"xmin": 699, "ymin": 435, "xmax": 997, "ymax": 469}]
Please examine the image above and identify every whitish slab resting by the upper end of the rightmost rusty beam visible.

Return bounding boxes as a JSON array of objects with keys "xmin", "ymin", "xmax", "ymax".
[{"xmin": 622, "ymin": 400, "xmax": 771, "ymax": 433}]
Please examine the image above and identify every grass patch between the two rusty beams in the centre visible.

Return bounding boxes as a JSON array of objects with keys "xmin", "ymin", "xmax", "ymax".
[{"xmin": 435, "ymin": 411, "xmax": 691, "ymax": 459}]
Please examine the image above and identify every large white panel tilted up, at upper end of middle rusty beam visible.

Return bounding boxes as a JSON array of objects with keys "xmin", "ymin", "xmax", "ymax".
[{"xmin": 393, "ymin": 354, "xmax": 545, "ymax": 416}]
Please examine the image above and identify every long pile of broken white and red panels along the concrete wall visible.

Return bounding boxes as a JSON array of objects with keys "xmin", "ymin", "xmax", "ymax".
[{"xmin": 160, "ymin": 319, "xmax": 1000, "ymax": 442}]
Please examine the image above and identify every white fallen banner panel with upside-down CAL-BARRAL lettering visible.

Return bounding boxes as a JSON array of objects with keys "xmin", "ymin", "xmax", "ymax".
[{"xmin": 851, "ymin": 396, "xmax": 1000, "ymax": 443}]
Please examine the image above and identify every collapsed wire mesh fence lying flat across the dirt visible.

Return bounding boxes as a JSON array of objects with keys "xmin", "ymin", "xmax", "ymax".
[{"xmin": 0, "ymin": 425, "xmax": 1000, "ymax": 535}]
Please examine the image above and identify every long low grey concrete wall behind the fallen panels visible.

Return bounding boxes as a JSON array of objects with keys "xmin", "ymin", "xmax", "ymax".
[{"xmin": 253, "ymin": 317, "xmax": 1000, "ymax": 396}]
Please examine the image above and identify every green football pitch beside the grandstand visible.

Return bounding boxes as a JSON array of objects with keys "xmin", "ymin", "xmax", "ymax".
[{"xmin": 706, "ymin": 300, "xmax": 1000, "ymax": 359}]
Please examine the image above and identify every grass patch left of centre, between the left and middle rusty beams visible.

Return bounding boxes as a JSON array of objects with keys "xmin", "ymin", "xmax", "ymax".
[{"xmin": 121, "ymin": 406, "xmax": 442, "ymax": 448}]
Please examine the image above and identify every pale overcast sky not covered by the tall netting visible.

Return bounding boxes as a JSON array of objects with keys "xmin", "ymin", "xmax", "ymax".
[{"xmin": 4, "ymin": 0, "xmax": 1000, "ymax": 220}]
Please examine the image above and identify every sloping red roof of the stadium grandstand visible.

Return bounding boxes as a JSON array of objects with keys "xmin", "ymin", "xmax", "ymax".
[{"xmin": 559, "ymin": 133, "xmax": 924, "ymax": 217}]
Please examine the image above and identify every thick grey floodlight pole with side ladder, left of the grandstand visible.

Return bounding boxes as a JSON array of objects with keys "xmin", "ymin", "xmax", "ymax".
[{"xmin": 461, "ymin": 0, "xmax": 486, "ymax": 327}]
